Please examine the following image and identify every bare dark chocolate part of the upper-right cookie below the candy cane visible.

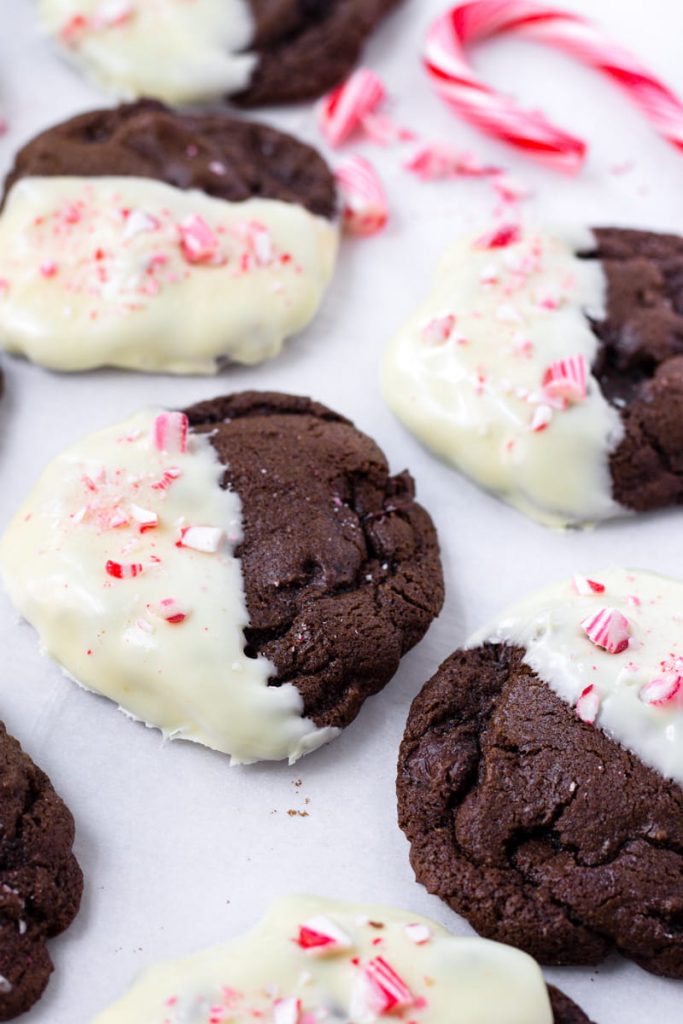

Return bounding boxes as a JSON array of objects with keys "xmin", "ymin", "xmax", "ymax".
[{"xmin": 587, "ymin": 227, "xmax": 683, "ymax": 512}]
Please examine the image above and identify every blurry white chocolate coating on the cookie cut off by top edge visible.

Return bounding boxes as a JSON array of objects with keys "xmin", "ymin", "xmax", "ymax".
[{"xmin": 38, "ymin": 0, "xmax": 257, "ymax": 103}]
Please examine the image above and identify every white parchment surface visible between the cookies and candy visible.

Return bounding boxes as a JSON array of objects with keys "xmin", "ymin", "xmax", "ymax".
[{"xmin": 0, "ymin": 0, "xmax": 683, "ymax": 1024}]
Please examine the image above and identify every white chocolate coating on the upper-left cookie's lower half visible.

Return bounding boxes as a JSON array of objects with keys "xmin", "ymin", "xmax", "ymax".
[{"xmin": 0, "ymin": 177, "xmax": 338, "ymax": 374}]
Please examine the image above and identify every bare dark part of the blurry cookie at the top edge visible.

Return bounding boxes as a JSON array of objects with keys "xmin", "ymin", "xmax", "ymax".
[{"xmin": 236, "ymin": 0, "xmax": 400, "ymax": 106}]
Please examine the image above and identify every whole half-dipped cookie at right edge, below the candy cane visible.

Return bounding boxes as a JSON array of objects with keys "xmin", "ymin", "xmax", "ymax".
[{"xmin": 383, "ymin": 225, "xmax": 683, "ymax": 526}]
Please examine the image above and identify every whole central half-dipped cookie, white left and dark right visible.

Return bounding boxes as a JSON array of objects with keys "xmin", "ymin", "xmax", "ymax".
[{"xmin": 0, "ymin": 392, "xmax": 443, "ymax": 762}]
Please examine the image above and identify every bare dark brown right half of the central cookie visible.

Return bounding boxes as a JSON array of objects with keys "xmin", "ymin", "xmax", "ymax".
[{"xmin": 185, "ymin": 392, "xmax": 443, "ymax": 727}]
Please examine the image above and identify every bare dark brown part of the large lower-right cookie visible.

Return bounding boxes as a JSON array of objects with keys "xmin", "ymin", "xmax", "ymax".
[{"xmin": 397, "ymin": 645, "xmax": 683, "ymax": 978}]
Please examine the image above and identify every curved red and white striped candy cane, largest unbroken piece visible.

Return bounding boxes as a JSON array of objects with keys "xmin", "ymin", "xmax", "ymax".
[{"xmin": 424, "ymin": 0, "xmax": 683, "ymax": 173}]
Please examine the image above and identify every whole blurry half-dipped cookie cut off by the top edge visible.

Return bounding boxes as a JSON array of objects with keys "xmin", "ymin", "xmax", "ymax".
[{"xmin": 38, "ymin": 0, "xmax": 399, "ymax": 106}]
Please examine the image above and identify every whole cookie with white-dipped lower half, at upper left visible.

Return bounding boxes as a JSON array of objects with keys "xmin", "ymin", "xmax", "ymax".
[{"xmin": 0, "ymin": 101, "xmax": 339, "ymax": 373}]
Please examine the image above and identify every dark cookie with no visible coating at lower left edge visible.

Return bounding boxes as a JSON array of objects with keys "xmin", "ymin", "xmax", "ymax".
[{"xmin": 0, "ymin": 722, "xmax": 83, "ymax": 1021}]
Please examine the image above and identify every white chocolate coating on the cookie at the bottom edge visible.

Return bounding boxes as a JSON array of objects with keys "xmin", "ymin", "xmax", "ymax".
[{"xmin": 92, "ymin": 896, "xmax": 553, "ymax": 1024}]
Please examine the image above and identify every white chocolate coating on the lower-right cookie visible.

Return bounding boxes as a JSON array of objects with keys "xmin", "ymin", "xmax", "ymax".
[{"xmin": 467, "ymin": 568, "xmax": 683, "ymax": 785}]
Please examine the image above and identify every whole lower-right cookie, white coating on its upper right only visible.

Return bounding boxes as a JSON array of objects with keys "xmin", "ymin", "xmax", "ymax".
[{"xmin": 397, "ymin": 570, "xmax": 683, "ymax": 978}]
